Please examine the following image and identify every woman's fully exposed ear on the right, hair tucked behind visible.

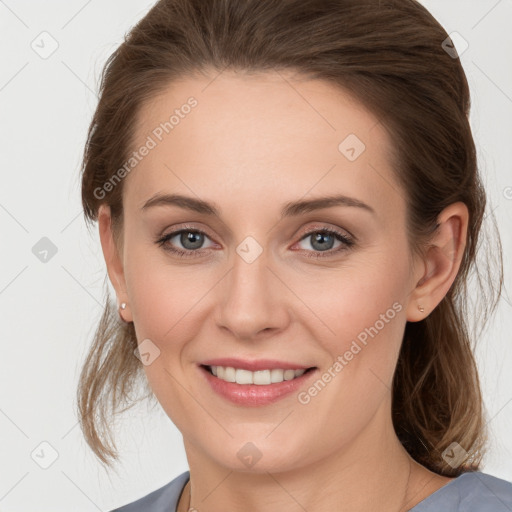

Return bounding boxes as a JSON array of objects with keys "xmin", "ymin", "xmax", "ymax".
[{"xmin": 407, "ymin": 201, "xmax": 469, "ymax": 322}]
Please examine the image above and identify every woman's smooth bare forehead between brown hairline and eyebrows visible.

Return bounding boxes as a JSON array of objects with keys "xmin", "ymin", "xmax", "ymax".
[{"xmin": 125, "ymin": 71, "xmax": 402, "ymax": 218}]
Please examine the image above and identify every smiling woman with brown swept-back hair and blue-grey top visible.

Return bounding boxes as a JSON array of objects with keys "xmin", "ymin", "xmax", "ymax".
[{"xmin": 78, "ymin": 0, "xmax": 512, "ymax": 512}]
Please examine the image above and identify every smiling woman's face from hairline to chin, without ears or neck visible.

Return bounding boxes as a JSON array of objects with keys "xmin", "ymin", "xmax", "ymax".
[{"xmin": 101, "ymin": 72, "xmax": 428, "ymax": 472}]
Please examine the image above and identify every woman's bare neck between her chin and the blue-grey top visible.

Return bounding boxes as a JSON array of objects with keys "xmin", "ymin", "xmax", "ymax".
[{"xmin": 178, "ymin": 400, "xmax": 433, "ymax": 512}]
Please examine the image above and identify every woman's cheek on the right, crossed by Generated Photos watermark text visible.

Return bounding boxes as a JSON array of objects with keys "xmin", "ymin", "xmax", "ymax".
[{"xmin": 298, "ymin": 254, "xmax": 407, "ymax": 396}]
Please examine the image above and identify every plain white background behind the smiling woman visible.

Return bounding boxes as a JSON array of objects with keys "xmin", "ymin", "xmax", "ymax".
[{"xmin": 0, "ymin": 0, "xmax": 512, "ymax": 512}]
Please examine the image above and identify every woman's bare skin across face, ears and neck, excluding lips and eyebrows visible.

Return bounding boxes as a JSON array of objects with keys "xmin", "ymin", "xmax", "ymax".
[{"xmin": 99, "ymin": 71, "xmax": 468, "ymax": 512}]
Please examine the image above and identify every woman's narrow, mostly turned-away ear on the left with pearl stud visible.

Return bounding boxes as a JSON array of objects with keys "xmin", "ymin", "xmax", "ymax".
[{"xmin": 98, "ymin": 204, "xmax": 133, "ymax": 322}]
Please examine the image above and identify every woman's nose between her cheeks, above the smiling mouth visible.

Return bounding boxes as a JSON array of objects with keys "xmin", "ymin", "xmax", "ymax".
[{"xmin": 216, "ymin": 243, "xmax": 290, "ymax": 340}]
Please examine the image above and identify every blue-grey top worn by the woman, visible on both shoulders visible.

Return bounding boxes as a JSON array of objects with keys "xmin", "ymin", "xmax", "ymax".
[{"xmin": 111, "ymin": 471, "xmax": 512, "ymax": 512}]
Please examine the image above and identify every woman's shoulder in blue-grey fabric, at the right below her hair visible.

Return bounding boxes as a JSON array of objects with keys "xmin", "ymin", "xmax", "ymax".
[{"xmin": 410, "ymin": 471, "xmax": 512, "ymax": 512}]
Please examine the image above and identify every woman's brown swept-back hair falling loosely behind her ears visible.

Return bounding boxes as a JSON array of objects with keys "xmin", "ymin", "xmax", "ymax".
[{"xmin": 77, "ymin": 0, "xmax": 503, "ymax": 477}]
